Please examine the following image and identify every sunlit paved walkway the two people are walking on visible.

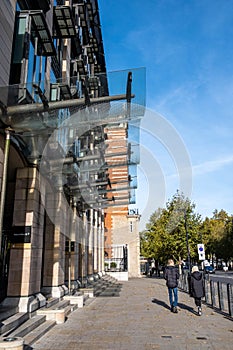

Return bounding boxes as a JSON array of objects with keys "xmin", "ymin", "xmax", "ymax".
[{"xmin": 32, "ymin": 277, "xmax": 233, "ymax": 350}]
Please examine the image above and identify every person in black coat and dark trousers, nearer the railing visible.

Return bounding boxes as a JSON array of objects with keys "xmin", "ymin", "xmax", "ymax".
[{"xmin": 190, "ymin": 266, "xmax": 205, "ymax": 316}]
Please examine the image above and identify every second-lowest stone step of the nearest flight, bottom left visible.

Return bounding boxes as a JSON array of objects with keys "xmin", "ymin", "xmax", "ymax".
[{"xmin": 4, "ymin": 315, "xmax": 45, "ymax": 338}]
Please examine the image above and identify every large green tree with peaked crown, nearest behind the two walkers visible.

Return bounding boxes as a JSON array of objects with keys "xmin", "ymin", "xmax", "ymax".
[{"xmin": 141, "ymin": 191, "xmax": 201, "ymax": 261}]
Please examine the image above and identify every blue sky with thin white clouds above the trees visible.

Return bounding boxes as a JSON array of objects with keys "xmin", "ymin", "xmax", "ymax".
[{"xmin": 99, "ymin": 0, "xmax": 233, "ymax": 229}]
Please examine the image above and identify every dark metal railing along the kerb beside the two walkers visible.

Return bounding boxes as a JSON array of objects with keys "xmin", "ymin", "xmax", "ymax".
[{"xmin": 179, "ymin": 271, "xmax": 233, "ymax": 317}]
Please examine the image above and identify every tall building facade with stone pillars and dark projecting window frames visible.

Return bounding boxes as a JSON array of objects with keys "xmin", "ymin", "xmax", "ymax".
[{"xmin": 0, "ymin": 0, "xmax": 145, "ymax": 311}]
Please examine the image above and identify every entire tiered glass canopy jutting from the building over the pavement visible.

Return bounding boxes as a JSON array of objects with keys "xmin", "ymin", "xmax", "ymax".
[{"xmin": 0, "ymin": 69, "xmax": 145, "ymax": 208}]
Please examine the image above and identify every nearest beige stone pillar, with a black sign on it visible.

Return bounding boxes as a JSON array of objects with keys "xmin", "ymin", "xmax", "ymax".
[{"xmin": 6, "ymin": 168, "xmax": 44, "ymax": 311}]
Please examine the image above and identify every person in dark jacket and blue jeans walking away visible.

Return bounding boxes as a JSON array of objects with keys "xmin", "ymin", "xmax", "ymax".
[{"xmin": 164, "ymin": 259, "xmax": 179, "ymax": 313}]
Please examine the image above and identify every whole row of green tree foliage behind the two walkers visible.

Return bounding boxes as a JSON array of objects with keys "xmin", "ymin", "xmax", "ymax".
[{"xmin": 141, "ymin": 191, "xmax": 233, "ymax": 262}]
